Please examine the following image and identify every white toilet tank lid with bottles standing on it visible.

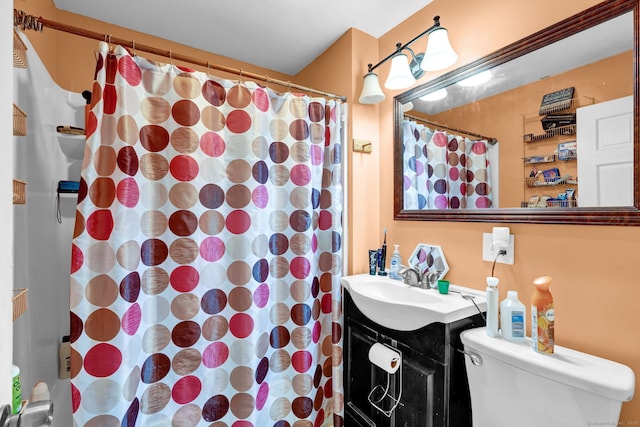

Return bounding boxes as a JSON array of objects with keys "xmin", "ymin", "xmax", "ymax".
[{"xmin": 460, "ymin": 327, "xmax": 635, "ymax": 402}]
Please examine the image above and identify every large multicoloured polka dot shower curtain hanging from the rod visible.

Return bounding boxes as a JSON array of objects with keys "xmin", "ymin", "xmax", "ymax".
[{"xmin": 71, "ymin": 44, "xmax": 346, "ymax": 427}]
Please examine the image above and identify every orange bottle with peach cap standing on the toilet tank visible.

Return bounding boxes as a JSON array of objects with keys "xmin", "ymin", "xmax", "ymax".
[{"xmin": 531, "ymin": 276, "xmax": 555, "ymax": 354}]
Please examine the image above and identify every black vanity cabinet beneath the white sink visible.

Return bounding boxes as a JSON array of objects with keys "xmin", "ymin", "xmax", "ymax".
[{"xmin": 344, "ymin": 291, "xmax": 484, "ymax": 427}]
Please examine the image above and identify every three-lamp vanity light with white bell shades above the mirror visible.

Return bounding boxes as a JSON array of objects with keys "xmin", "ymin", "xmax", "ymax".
[{"xmin": 359, "ymin": 16, "xmax": 458, "ymax": 104}]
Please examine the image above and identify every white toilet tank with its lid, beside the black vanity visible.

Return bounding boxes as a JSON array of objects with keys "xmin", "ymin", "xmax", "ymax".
[{"xmin": 460, "ymin": 328, "xmax": 635, "ymax": 427}]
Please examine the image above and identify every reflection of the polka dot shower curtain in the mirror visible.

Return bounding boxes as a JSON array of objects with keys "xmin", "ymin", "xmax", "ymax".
[{"xmin": 402, "ymin": 120, "xmax": 493, "ymax": 210}]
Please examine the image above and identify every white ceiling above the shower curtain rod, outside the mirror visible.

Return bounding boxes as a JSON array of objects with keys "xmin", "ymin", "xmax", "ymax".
[{"xmin": 54, "ymin": 0, "xmax": 432, "ymax": 75}]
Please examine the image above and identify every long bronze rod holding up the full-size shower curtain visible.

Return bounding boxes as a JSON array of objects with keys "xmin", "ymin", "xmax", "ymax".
[{"xmin": 13, "ymin": 9, "xmax": 347, "ymax": 102}]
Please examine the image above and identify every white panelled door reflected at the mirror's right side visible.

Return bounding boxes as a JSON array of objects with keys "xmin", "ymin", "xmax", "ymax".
[{"xmin": 576, "ymin": 96, "xmax": 633, "ymax": 207}]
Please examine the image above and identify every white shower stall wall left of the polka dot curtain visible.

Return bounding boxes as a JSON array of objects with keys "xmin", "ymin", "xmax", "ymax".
[{"xmin": 13, "ymin": 34, "xmax": 85, "ymax": 427}]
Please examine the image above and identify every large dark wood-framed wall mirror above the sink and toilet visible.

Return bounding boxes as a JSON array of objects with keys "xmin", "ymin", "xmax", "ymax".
[{"xmin": 394, "ymin": 0, "xmax": 640, "ymax": 225}]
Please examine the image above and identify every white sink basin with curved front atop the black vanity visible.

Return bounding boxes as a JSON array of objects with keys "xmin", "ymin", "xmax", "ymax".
[{"xmin": 341, "ymin": 274, "xmax": 487, "ymax": 331}]
